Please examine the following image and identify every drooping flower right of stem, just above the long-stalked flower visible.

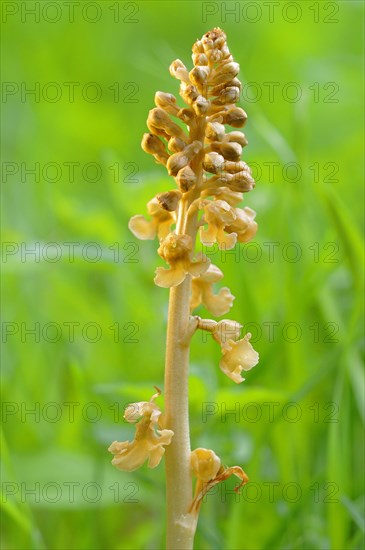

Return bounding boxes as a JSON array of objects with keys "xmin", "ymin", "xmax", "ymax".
[{"xmin": 190, "ymin": 264, "xmax": 234, "ymax": 317}]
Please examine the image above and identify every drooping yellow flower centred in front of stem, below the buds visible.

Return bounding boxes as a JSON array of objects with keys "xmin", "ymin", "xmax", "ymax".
[{"xmin": 155, "ymin": 233, "xmax": 210, "ymax": 288}]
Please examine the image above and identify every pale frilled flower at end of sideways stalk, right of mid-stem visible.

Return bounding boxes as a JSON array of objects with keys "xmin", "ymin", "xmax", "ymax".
[{"xmin": 219, "ymin": 333, "xmax": 259, "ymax": 384}]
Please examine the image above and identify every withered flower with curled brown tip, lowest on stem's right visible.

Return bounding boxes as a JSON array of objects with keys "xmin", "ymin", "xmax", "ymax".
[{"xmin": 187, "ymin": 448, "xmax": 248, "ymax": 522}]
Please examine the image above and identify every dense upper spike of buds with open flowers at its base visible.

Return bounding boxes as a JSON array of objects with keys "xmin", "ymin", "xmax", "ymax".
[{"xmin": 129, "ymin": 28, "xmax": 257, "ymax": 294}]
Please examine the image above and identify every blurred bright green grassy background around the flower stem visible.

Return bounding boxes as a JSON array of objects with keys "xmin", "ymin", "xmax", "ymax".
[{"xmin": 2, "ymin": 1, "xmax": 364, "ymax": 549}]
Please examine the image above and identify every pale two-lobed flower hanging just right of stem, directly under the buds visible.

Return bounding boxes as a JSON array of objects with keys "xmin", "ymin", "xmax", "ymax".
[{"xmin": 200, "ymin": 200, "xmax": 237, "ymax": 250}]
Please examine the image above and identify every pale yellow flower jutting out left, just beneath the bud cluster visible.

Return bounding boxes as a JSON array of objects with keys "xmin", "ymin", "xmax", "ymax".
[{"xmin": 128, "ymin": 197, "xmax": 175, "ymax": 240}]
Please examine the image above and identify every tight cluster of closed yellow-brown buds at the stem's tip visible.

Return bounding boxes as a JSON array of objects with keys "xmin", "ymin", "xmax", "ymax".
[{"xmin": 138, "ymin": 28, "xmax": 254, "ymax": 203}]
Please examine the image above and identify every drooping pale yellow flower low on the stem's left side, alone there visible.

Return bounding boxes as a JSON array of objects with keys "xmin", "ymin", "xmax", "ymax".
[{"xmin": 108, "ymin": 390, "xmax": 174, "ymax": 472}]
